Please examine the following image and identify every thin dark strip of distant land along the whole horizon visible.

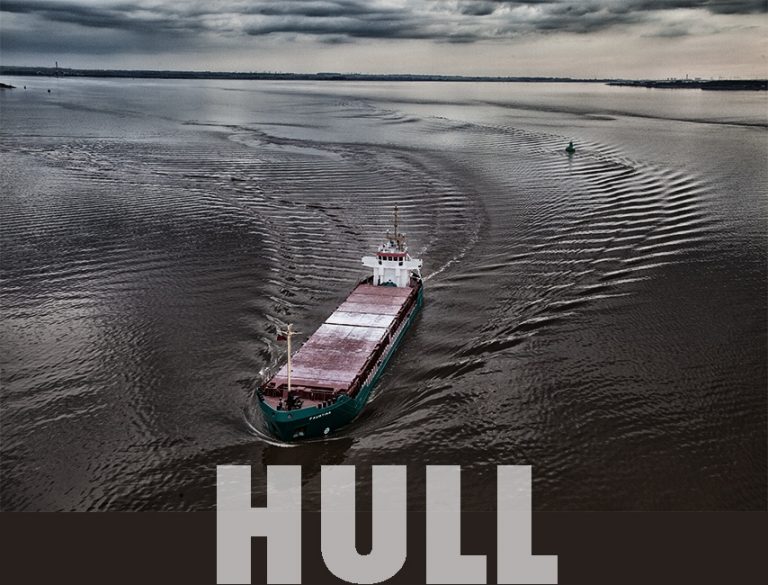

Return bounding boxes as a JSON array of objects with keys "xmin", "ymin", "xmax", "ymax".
[{"xmin": 0, "ymin": 65, "xmax": 768, "ymax": 91}]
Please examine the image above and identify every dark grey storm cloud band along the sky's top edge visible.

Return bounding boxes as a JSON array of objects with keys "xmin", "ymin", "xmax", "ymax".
[{"xmin": 0, "ymin": 0, "xmax": 766, "ymax": 51}]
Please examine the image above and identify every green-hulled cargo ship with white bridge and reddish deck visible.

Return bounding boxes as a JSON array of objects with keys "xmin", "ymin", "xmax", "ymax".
[{"xmin": 257, "ymin": 207, "xmax": 424, "ymax": 441}]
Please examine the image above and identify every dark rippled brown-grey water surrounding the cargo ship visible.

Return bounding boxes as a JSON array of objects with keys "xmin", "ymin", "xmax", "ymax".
[{"xmin": 0, "ymin": 78, "xmax": 768, "ymax": 510}]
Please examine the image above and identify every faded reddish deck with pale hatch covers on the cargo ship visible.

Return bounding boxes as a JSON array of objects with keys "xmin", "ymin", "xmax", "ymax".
[{"xmin": 265, "ymin": 284, "xmax": 416, "ymax": 407}]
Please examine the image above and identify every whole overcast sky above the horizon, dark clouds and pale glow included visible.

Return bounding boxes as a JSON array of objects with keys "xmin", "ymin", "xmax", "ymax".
[{"xmin": 0, "ymin": 0, "xmax": 768, "ymax": 78}]
